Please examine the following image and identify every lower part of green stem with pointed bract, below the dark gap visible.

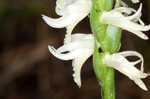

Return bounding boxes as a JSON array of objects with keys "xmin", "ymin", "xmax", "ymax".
[{"xmin": 93, "ymin": 44, "xmax": 115, "ymax": 99}]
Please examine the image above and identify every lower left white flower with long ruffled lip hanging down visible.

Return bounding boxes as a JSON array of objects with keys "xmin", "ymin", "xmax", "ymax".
[{"xmin": 48, "ymin": 34, "xmax": 94, "ymax": 87}]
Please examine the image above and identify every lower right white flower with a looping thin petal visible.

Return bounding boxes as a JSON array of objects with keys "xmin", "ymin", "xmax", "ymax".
[{"xmin": 104, "ymin": 51, "xmax": 149, "ymax": 91}]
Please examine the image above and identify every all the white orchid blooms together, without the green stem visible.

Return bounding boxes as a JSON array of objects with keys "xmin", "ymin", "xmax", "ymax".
[{"xmin": 42, "ymin": 0, "xmax": 150, "ymax": 90}]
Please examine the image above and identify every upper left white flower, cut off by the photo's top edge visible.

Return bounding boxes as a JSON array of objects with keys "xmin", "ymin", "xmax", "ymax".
[{"xmin": 42, "ymin": 0, "xmax": 92, "ymax": 43}]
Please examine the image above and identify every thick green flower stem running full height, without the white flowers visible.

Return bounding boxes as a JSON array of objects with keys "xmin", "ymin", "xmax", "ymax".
[{"xmin": 90, "ymin": 0, "xmax": 121, "ymax": 99}]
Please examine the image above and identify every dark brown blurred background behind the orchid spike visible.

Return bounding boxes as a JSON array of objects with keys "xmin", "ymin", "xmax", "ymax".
[{"xmin": 0, "ymin": 0, "xmax": 150, "ymax": 99}]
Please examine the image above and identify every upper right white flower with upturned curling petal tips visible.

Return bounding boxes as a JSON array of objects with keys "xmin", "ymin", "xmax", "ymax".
[{"xmin": 100, "ymin": 4, "xmax": 150, "ymax": 39}]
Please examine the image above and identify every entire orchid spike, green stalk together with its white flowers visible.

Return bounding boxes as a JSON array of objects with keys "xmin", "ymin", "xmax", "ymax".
[{"xmin": 42, "ymin": 0, "xmax": 150, "ymax": 99}]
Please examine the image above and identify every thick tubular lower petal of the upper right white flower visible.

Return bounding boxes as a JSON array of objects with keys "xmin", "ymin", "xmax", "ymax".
[{"xmin": 101, "ymin": 12, "xmax": 150, "ymax": 40}]
